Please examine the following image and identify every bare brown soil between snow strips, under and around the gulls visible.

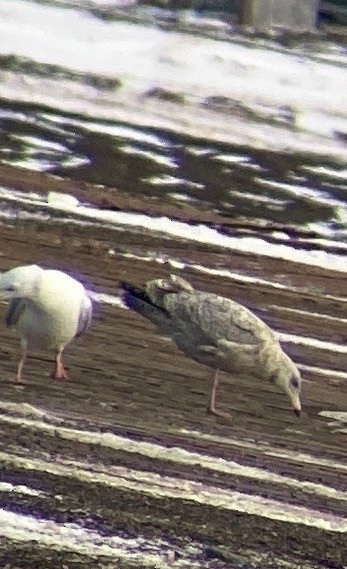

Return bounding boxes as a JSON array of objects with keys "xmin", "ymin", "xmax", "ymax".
[{"xmin": 0, "ymin": 167, "xmax": 347, "ymax": 568}]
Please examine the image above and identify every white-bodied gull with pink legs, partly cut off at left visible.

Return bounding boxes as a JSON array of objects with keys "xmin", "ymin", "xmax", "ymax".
[{"xmin": 0, "ymin": 265, "xmax": 92, "ymax": 381}]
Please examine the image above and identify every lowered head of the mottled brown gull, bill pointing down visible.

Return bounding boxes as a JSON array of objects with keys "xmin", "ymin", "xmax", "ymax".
[{"xmin": 272, "ymin": 352, "xmax": 301, "ymax": 417}]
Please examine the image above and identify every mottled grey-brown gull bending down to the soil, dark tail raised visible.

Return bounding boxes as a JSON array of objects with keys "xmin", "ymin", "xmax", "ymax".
[{"xmin": 121, "ymin": 275, "xmax": 301, "ymax": 417}]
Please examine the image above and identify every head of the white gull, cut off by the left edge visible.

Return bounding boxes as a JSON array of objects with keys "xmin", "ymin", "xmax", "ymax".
[{"xmin": 0, "ymin": 265, "xmax": 43, "ymax": 300}]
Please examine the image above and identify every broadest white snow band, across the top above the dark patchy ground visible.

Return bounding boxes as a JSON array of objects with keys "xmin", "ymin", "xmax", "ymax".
[{"xmin": 0, "ymin": 0, "xmax": 347, "ymax": 157}]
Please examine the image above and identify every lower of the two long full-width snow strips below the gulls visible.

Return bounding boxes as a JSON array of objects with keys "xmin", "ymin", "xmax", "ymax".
[{"xmin": 0, "ymin": 452, "xmax": 347, "ymax": 540}]
